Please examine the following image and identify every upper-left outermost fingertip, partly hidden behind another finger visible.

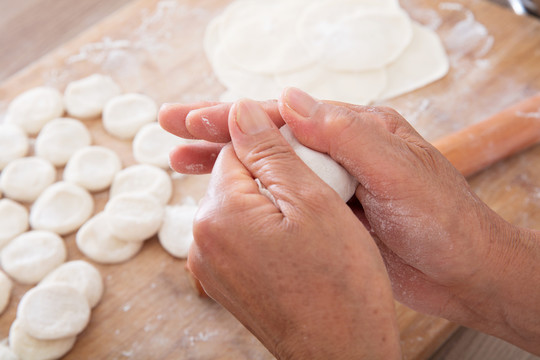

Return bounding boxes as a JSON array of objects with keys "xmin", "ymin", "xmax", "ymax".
[{"xmin": 158, "ymin": 101, "xmax": 218, "ymax": 139}]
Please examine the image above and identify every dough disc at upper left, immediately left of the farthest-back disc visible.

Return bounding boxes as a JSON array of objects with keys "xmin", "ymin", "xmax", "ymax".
[{"xmin": 5, "ymin": 86, "xmax": 64, "ymax": 135}]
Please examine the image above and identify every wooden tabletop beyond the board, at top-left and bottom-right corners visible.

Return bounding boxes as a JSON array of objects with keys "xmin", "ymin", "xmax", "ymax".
[{"xmin": 0, "ymin": 0, "xmax": 538, "ymax": 360}]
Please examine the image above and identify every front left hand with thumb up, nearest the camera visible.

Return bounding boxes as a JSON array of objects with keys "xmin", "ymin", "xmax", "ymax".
[{"xmin": 188, "ymin": 100, "xmax": 400, "ymax": 359}]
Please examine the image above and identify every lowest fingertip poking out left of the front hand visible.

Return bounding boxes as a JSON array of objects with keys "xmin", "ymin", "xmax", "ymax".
[{"xmin": 169, "ymin": 142, "xmax": 225, "ymax": 175}]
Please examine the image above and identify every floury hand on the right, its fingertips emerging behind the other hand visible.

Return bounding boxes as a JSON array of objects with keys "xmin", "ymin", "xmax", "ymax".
[{"xmin": 160, "ymin": 89, "xmax": 540, "ymax": 351}]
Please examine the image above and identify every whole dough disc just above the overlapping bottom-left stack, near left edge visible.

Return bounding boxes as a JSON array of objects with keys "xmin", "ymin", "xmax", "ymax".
[{"xmin": 1, "ymin": 230, "xmax": 67, "ymax": 284}]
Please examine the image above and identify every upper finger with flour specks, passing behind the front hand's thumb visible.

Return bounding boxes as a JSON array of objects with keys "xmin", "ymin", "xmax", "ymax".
[{"xmin": 185, "ymin": 100, "xmax": 284, "ymax": 143}]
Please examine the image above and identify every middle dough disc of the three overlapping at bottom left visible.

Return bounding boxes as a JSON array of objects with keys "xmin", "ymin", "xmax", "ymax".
[{"xmin": 17, "ymin": 284, "xmax": 90, "ymax": 340}]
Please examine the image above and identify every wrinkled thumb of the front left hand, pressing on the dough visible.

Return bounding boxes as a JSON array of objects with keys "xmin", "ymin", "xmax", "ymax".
[{"xmin": 229, "ymin": 100, "xmax": 342, "ymax": 216}]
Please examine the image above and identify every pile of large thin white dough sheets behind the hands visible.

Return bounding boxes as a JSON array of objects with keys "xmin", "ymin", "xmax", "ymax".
[{"xmin": 204, "ymin": 0, "xmax": 449, "ymax": 104}]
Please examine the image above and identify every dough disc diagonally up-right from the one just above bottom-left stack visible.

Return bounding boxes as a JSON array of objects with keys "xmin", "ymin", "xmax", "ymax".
[{"xmin": 30, "ymin": 181, "xmax": 94, "ymax": 235}]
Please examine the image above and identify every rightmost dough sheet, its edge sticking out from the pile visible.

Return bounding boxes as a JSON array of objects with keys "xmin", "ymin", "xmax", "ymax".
[{"xmin": 380, "ymin": 23, "xmax": 450, "ymax": 99}]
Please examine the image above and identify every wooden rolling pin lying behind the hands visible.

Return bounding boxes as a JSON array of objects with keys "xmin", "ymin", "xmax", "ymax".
[{"xmin": 186, "ymin": 93, "xmax": 540, "ymax": 297}]
